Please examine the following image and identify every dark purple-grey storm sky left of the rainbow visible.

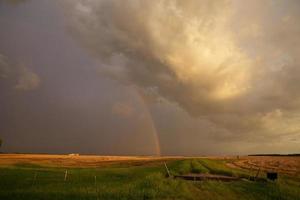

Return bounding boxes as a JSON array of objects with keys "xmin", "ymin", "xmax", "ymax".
[{"xmin": 0, "ymin": 0, "xmax": 158, "ymax": 155}]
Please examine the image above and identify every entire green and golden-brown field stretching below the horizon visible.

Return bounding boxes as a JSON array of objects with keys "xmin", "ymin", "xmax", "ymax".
[{"xmin": 0, "ymin": 154, "xmax": 300, "ymax": 200}]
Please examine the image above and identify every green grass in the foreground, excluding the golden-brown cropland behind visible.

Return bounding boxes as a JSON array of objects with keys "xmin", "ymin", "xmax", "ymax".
[{"xmin": 0, "ymin": 159, "xmax": 300, "ymax": 200}]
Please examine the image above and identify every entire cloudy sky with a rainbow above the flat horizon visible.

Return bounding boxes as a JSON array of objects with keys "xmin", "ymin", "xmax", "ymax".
[{"xmin": 0, "ymin": 0, "xmax": 300, "ymax": 156}]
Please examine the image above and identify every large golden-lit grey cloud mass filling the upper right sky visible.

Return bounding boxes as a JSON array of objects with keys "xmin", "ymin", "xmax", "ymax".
[{"xmin": 64, "ymin": 0, "xmax": 300, "ymax": 150}]
